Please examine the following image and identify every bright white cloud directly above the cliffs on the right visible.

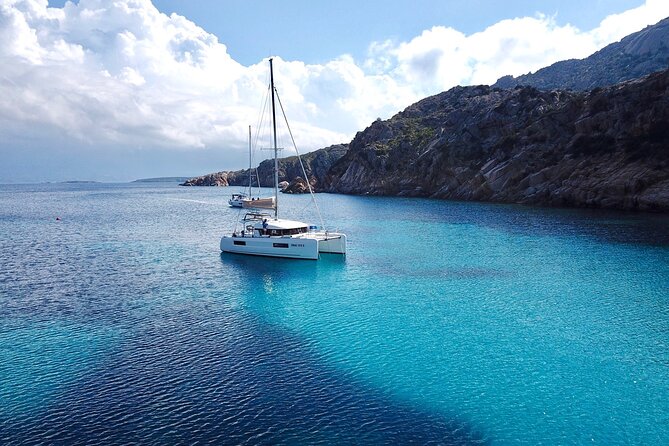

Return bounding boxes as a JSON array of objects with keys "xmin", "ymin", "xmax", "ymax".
[{"xmin": 364, "ymin": 0, "xmax": 669, "ymax": 98}]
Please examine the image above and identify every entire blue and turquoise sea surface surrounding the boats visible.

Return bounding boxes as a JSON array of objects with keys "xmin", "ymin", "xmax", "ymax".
[{"xmin": 0, "ymin": 184, "xmax": 669, "ymax": 444}]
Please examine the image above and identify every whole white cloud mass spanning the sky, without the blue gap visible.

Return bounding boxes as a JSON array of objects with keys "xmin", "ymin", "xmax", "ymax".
[{"xmin": 0, "ymin": 0, "xmax": 669, "ymax": 181}]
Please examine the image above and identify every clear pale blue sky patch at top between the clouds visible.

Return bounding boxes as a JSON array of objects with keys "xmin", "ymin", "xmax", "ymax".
[{"xmin": 49, "ymin": 0, "xmax": 642, "ymax": 65}]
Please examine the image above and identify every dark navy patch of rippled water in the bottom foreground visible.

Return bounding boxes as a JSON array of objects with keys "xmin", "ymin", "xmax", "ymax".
[{"xmin": 0, "ymin": 301, "xmax": 490, "ymax": 445}]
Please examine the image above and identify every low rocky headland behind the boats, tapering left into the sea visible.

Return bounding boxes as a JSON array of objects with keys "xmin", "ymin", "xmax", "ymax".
[{"xmin": 181, "ymin": 144, "xmax": 348, "ymax": 193}]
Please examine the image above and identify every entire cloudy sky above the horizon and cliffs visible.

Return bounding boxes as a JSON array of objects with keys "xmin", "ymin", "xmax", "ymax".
[{"xmin": 0, "ymin": 0, "xmax": 669, "ymax": 183}]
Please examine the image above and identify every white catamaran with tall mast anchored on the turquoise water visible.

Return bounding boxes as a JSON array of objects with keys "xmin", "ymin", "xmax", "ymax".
[{"xmin": 220, "ymin": 59, "xmax": 346, "ymax": 260}]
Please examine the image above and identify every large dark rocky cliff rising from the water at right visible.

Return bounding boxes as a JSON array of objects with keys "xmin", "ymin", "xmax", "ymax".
[{"xmin": 319, "ymin": 71, "xmax": 669, "ymax": 211}]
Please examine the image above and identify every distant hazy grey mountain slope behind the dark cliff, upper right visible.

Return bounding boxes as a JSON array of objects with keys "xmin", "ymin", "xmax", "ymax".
[{"xmin": 493, "ymin": 18, "xmax": 669, "ymax": 91}]
